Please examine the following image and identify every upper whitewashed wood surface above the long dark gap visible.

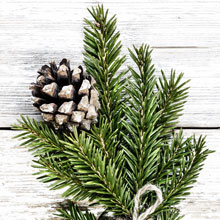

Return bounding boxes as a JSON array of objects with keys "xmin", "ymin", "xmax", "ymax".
[{"xmin": 0, "ymin": 0, "xmax": 220, "ymax": 127}]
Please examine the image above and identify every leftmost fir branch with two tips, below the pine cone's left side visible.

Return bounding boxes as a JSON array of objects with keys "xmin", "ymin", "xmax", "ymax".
[{"xmin": 13, "ymin": 116, "xmax": 88, "ymax": 200}]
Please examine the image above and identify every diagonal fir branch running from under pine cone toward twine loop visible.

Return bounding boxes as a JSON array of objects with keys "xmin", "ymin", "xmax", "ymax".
[{"xmin": 63, "ymin": 130, "xmax": 131, "ymax": 216}]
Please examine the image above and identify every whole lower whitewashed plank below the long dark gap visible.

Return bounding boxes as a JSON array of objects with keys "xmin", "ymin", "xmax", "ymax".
[{"xmin": 0, "ymin": 129, "xmax": 220, "ymax": 220}]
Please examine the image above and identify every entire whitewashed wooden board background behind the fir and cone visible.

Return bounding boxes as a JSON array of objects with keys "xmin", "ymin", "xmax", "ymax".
[{"xmin": 0, "ymin": 0, "xmax": 220, "ymax": 220}]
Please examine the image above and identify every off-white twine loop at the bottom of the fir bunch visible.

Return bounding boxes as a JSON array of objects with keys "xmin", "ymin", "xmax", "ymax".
[{"xmin": 133, "ymin": 184, "xmax": 163, "ymax": 220}]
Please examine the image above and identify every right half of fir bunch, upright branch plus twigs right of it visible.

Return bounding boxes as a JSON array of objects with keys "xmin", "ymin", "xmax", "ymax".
[{"xmin": 123, "ymin": 45, "xmax": 210, "ymax": 218}]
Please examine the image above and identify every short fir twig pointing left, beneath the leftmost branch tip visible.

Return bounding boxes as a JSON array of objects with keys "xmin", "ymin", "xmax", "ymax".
[{"xmin": 33, "ymin": 153, "xmax": 90, "ymax": 201}]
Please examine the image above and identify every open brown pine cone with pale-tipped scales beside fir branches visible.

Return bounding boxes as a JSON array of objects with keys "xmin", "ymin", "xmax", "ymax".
[{"xmin": 30, "ymin": 59, "xmax": 100, "ymax": 130}]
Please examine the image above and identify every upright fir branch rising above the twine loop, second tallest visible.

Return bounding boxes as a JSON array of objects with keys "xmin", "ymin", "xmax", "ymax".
[{"xmin": 123, "ymin": 45, "xmax": 161, "ymax": 194}]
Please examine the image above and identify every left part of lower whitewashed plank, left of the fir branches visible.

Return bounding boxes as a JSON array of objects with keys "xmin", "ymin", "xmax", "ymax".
[{"xmin": 0, "ymin": 130, "xmax": 61, "ymax": 220}]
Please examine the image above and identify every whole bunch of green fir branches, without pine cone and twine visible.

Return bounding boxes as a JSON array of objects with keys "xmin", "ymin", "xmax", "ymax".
[{"xmin": 14, "ymin": 3, "xmax": 211, "ymax": 220}]
